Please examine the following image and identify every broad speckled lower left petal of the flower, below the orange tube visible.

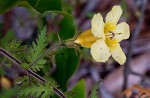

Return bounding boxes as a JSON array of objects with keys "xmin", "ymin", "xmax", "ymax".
[{"xmin": 91, "ymin": 39, "xmax": 111, "ymax": 62}]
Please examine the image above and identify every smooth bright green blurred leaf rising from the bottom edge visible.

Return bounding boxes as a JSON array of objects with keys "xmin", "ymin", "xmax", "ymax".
[{"xmin": 72, "ymin": 80, "xmax": 86, "ymax": 98}]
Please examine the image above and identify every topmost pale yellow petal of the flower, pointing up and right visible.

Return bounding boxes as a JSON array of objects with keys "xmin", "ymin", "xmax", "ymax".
[{"xmin": 106, "ymin": 5, "xmax": 122, "ymax": 24}]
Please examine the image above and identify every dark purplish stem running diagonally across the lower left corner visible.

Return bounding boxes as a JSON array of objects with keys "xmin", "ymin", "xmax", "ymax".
[{"xmin": 0, "ymin": 48, "xmax": 66, "ymax": 98}]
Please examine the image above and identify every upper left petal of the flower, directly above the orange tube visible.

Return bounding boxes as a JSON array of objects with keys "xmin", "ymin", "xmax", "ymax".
[{"xmin": 92, "ymin": 13, "xmax": 105, "ymax": 38}]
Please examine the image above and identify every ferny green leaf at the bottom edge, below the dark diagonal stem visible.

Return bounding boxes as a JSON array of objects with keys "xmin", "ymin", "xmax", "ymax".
[{"xmin": 19, "ymin": 84, "xmax": 53, "ymax": 98}]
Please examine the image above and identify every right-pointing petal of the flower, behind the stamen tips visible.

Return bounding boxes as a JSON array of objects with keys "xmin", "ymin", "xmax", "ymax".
[{"xmin": 114, "ymin": 22, "xmax": 130, "ymax": 42}]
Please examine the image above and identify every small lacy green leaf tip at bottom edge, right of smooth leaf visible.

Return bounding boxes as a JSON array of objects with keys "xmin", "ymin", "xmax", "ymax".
[{"xmin": 90, "ymin": 81, "xmax": 100, "ymax": 98}]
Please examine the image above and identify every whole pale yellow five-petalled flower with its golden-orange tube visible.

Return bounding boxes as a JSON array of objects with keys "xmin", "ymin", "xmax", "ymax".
[{"xmin": 74, "ymin": 5, "xmax": 130, "ymax": 65}]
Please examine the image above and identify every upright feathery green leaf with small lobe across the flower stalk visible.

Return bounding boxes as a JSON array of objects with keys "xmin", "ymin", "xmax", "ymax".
[{"xmin": 28, "ymin": 27, "xmax": 47, "ymax": 71}]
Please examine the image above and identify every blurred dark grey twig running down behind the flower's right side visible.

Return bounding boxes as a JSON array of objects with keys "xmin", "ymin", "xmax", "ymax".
[{"xmin": 122, "ymin": 0, "xmax": 147, "ymax": 90}]
